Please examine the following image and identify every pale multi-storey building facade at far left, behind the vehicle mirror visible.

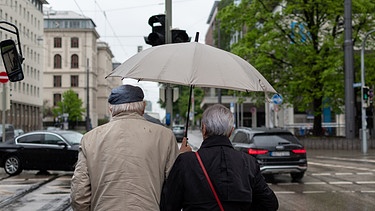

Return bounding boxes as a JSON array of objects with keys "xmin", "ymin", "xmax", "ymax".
[{"xmin": 0, "ymin": 0, "xmax": 47, "ymax": 132}]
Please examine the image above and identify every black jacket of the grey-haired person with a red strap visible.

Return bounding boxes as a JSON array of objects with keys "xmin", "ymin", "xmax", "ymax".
[{"xmin": 160, "ymin": 136, "xmax": 279, "ymax": 211}]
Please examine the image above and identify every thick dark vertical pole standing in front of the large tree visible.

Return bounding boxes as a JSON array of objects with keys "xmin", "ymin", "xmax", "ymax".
[{"xmin": 344, "ymin": 0, "xmax": 355, "ymax": 139}]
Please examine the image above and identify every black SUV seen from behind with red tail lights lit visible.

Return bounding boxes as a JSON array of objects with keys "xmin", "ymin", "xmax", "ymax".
[{"xmin": 231, "ymin": 128, "xmax": 307, "ymax": 180}]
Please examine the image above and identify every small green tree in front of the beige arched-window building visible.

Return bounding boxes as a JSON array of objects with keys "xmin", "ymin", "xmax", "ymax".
[{"xmin": 52, "ymin": 89, "xmax": 85, "ymax": 129}]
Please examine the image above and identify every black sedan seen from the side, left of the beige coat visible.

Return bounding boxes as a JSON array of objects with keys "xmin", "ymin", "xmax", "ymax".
[{"xmin": 0, "ymin": 130, "xmax": 83, "ymax": 176}]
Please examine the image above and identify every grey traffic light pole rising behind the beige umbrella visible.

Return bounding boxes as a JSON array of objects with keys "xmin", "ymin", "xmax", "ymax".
[{"xmin": 165, "ymin": 0, "xmax": 174, "ymax": 128}]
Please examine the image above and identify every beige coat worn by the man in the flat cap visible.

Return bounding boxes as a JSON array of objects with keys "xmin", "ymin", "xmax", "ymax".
[{"xmin": 71, "ymin": 113, "xmax": 179, "ymax": 211}]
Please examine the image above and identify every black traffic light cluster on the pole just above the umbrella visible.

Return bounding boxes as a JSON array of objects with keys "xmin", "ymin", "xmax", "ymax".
[{"xmin": 144, "ymin": 15, "xmax": 191, "ymax": 46}]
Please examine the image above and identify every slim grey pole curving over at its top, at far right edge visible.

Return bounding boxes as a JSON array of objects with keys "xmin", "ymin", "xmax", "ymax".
[{"xmin": 361, "ymin": 29, "xmax": 375, "ymax": 154}]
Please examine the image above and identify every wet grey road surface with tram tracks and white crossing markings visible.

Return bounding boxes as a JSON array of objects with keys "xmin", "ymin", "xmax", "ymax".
[{"xmin": 0, "ymin": 131, "xmax": 375, "ymax": 211}]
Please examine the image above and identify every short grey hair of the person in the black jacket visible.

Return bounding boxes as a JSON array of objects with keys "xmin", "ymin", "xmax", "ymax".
[{"xmin": 202, "ymin": 104, "xmax": 234, "ymax": 137}]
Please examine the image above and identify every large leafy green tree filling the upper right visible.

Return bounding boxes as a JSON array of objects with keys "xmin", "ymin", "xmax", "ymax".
[{"xmin": 218, "ymin": 0, "xmax": 375, "ymax": 135}]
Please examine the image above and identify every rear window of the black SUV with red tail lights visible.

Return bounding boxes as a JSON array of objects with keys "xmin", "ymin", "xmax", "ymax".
[{"xmin": 253, "ymin": 133, "xmax": 298, "ymax": 147}]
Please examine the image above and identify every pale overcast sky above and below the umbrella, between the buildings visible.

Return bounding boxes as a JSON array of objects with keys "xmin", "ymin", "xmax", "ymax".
[{"xmin": 45, "ymin": 0, "xmax": 215, "ymax": 119}]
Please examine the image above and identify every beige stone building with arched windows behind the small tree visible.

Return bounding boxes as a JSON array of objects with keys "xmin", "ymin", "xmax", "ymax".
[{"xmin": 43, "ymin": 10, "xmax": 121, "ymax": 127}]
